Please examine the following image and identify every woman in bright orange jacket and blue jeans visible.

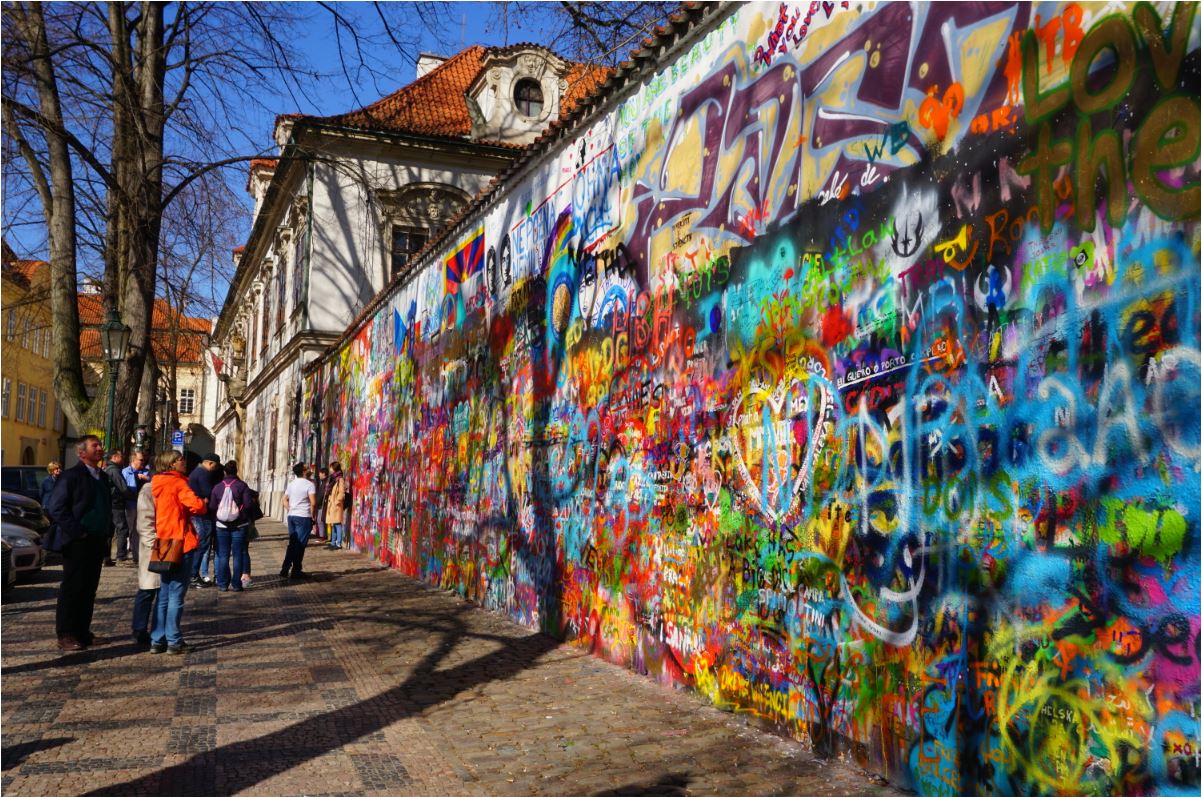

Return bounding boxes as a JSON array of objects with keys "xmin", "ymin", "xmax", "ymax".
[{"xmin": 150, "ymin": 451, "xmax": 208, "ymax": 654}]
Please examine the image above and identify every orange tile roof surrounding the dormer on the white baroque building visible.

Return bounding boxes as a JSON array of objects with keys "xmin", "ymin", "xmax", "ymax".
[{"xmin": 312, "ymin": 44, "xmax": 611, "ymax": 142}]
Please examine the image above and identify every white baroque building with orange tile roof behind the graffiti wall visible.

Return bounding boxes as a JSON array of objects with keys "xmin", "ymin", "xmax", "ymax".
[{"xmin": 214, "ymin": 44, "xmax": 608, "ymax": 513}]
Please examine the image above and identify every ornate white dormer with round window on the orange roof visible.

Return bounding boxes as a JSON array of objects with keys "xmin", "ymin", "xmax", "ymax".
[{"xmin": 468, "ymin": 44, "xmax": 572, "ymax": 144}]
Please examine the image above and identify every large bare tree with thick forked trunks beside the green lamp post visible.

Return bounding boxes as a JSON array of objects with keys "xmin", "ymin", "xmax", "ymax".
[{"xmin": 2, "ymin": 1, "xmax": 317, "ymax": 440}]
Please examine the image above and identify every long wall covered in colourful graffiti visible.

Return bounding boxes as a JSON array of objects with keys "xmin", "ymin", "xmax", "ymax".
[{"xmin": 302, "ymin": 2, "xmax": 1202, "ymax": 795}]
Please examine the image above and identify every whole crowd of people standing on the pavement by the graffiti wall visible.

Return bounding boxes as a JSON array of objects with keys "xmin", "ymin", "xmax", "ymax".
[{"xmin": 42, "ymin": 435, "xmax": 350, "ymax": 654}]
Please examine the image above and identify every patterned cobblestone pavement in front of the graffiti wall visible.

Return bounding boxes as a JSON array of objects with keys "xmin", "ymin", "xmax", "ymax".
[{"xmin": 0, "ymin": 523, "xmax": 898, "ymax": 797}]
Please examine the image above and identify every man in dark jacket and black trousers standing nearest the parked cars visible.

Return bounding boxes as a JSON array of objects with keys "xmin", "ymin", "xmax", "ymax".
[{"xmin": 48, "ymin": 434, "xmax": 113, "ymax": 650}]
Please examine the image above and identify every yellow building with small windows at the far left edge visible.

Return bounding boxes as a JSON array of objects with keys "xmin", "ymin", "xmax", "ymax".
[{"xmin": 0, "ymin": 246, "xmax": 64, "ymax": 465}]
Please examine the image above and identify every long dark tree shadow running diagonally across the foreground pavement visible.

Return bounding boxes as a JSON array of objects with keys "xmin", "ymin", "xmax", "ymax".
[{"xmin": 87, "ymin": 605, "xmax": 560, "ymax": 797}]
